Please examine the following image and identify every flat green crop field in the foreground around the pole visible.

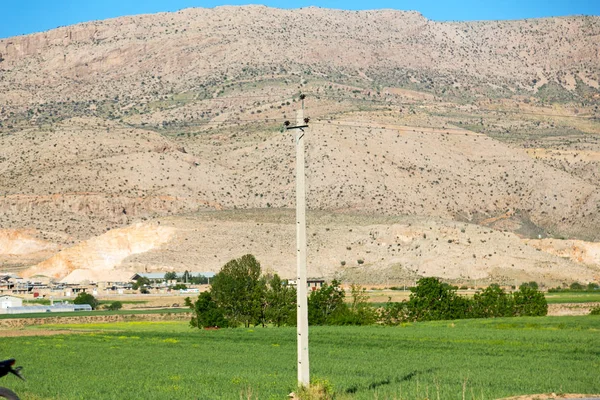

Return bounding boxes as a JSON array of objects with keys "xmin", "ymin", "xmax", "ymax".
[{"xmin": 0, "ymin": 316, "xmax": 600, "ymax": 400}]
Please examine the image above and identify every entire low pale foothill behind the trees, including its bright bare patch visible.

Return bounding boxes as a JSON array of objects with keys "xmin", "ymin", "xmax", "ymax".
[{"xmin": 5, "ymin": 210, "xmax": 600, "ymax": 286}]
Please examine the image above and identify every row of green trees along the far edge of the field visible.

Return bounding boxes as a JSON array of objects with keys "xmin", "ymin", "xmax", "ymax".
[{"xmin": 186, "ymin": 254, "xmax": 548, "ymax": 328}]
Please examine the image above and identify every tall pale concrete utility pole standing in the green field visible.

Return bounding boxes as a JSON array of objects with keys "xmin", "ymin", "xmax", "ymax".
[{"xmin": 285, "ymin": 95, "xmax": 310, "ymax": 387}]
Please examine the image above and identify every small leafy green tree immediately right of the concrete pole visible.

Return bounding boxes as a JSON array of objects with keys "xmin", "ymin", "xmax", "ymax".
[{"xmin": 308, "ymin": 280, "xmax": 348, "ymax": 325}]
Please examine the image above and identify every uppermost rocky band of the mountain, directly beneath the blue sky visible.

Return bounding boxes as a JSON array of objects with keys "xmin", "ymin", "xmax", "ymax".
[{"xmin": 0, "ymin": 6, "xmax": 600, "ymax": 108}]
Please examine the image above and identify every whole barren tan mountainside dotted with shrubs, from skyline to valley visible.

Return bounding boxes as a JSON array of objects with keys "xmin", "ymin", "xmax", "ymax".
[{"xmin": 0, "ymin": 6, "xmax": 600, "ymax": 283}]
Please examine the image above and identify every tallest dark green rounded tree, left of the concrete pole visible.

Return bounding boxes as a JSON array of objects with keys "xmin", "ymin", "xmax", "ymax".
[{"xmin": 211, "ymin": 254, "xmax": 265, "ymax": 327}]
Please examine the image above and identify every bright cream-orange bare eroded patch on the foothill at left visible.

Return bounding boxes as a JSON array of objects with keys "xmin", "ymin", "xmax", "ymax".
[{"xmin": 22, "ymin": 223, "xmax": 174, "ymax": 282}]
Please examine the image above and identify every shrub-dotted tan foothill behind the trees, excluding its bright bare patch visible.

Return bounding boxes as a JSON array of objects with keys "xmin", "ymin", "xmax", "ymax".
[{"xmin": 116, "ymin": 210, "xmax": 600, "ymax": 286}]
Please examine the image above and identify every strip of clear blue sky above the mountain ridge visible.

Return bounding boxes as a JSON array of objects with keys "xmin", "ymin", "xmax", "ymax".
[{"xmin": 0, "ymin": 0, "xmax": 600, "ymax": 38}]
